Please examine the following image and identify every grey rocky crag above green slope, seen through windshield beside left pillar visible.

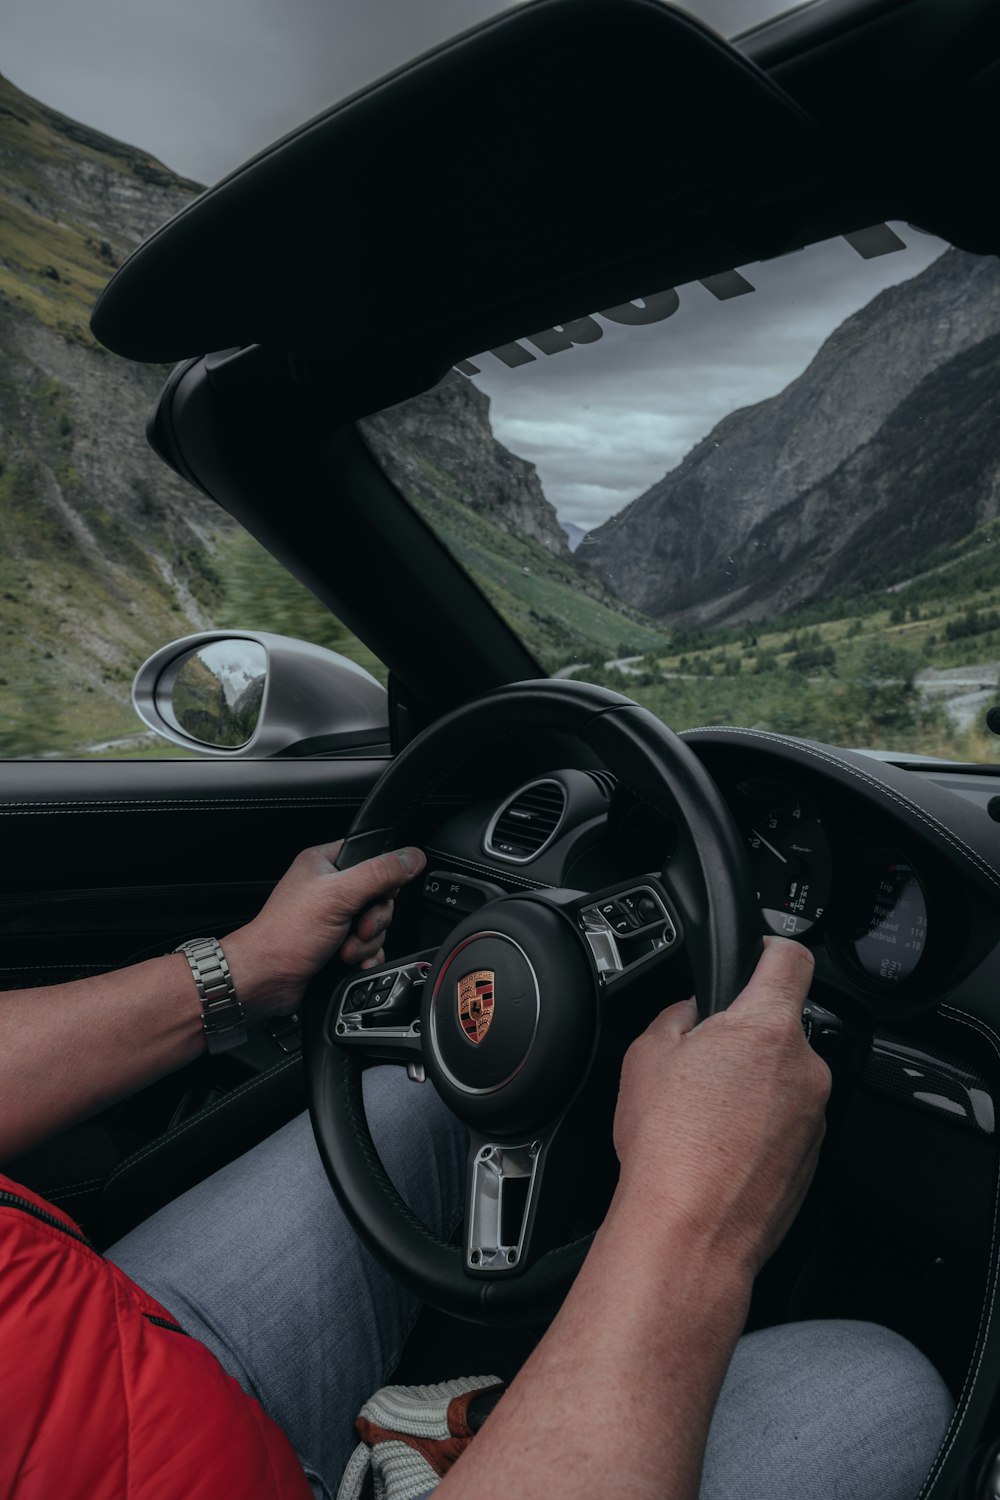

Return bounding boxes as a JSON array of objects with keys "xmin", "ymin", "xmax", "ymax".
[{"xmin": 363, "ymin": 380, "xmax": 570, "ymax": 558}]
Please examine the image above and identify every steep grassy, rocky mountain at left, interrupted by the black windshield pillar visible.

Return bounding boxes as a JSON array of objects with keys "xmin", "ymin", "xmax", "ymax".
[{"xmin": 0, "ymin": 78, "xmax": 663, "ymax": 756}]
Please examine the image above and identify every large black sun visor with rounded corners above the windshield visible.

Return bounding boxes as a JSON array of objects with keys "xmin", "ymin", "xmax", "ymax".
[{"xmin": 91, "ymin": 0, "xmax": 823, "ymax": 384}]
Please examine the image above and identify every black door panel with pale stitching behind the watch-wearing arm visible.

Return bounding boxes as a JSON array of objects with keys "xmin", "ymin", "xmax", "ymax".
[{"xmin": 0, "ymin": 759, "xmax": 385, "ymax": 1244}]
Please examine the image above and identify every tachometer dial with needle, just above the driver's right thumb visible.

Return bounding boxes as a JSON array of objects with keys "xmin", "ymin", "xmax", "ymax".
[{"xmin": 733, "ymin": 777, "xmax": 832, "ymax": 938}]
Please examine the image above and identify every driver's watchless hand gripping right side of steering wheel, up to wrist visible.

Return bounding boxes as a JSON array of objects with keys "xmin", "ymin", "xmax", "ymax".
[{"xmin": 615, "ymin": 938, "xmax": 831, "ymax": 1275}]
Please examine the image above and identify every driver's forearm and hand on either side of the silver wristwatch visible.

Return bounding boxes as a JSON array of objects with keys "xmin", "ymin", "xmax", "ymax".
[{"xmin": 0, "ymin": 842, "xmax": 424, "ymax": 1163}]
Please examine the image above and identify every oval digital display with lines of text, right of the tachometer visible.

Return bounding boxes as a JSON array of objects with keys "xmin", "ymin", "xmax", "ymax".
[{"xmin": 852, "ymin": 846, "xmax": 927, "ymax": 984}]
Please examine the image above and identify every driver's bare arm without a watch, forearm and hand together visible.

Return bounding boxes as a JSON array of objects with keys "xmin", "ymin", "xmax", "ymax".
[{"xmin": 441, "ymin": 942, "xmax": 829, "ymax": 1500}]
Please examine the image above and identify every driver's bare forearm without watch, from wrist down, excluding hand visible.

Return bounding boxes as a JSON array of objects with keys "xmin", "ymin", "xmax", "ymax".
[{"xmin": 438, "ymin": 1196, "xmax": 753, "ymax": 1500}]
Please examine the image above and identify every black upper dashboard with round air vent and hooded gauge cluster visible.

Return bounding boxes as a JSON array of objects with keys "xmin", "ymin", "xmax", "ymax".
[{"xmin": 413, "ymin": 729, "xmax": 1000, "ymax": 1022}]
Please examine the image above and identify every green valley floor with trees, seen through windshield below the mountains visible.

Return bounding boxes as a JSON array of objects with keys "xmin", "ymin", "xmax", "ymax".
[{"xmin": 581, "ymin": 527, "xmax": 1000, "ymax": 761}]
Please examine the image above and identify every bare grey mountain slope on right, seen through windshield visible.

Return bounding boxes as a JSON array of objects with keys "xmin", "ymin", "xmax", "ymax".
[{"xmin": 577, "ymin": 251, "xmax": 1000, "ymax": 626}]
